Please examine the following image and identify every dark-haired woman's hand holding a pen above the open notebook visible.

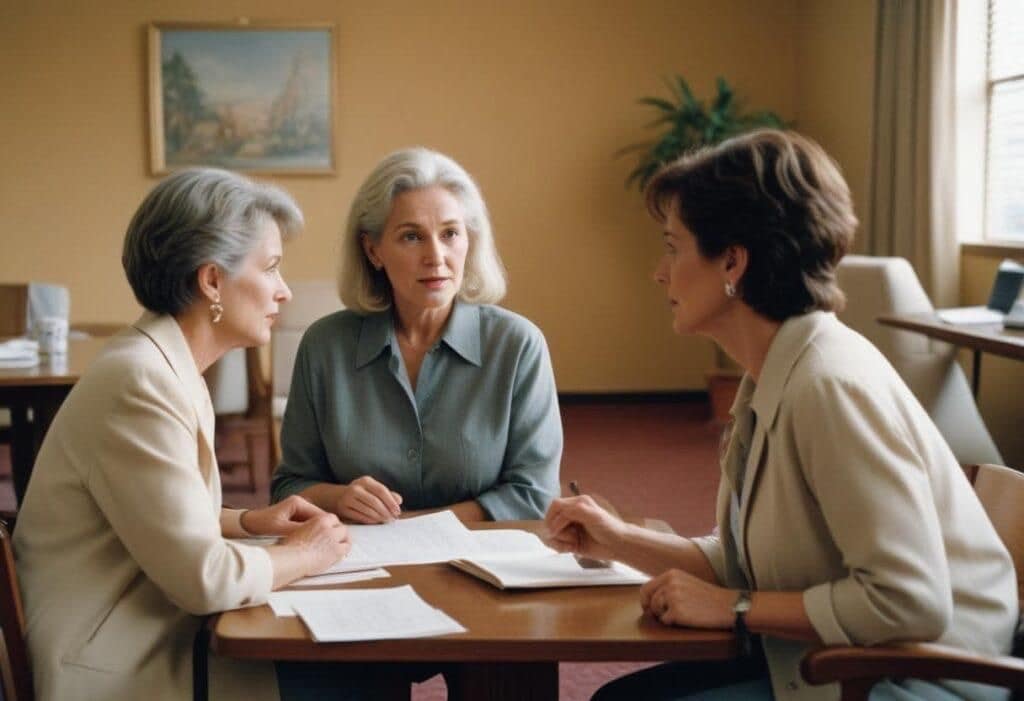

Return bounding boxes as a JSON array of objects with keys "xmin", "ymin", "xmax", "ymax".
[{"xmin": 544, "ymin": 495, "xmax": 628, "ymax": 560}]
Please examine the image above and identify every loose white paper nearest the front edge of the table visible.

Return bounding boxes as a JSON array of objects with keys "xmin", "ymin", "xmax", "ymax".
[{"xmin": 281, "ymin": 584, "xmax": 466, "ymax": 643}]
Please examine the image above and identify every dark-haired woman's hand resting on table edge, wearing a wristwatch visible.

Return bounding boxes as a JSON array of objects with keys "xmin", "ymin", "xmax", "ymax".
[{"xmin": 640, "ymin": 570, "xmax": 737, "ymax": 629}]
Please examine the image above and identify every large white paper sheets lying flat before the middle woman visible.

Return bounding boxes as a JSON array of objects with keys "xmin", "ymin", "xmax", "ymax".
[{"xmin": 327, "ymin": 511, "xmax": 550, "ymax": 572}]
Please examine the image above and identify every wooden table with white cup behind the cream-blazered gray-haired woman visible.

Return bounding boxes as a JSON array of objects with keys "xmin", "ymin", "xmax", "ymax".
[{"xmin": 0, "ymin": 337, "xmax": 110, "ymax": 505}]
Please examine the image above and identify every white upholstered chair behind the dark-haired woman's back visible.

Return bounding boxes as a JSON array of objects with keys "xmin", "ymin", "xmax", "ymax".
[{"xmin": 837, "ymin": 256, "xmax": 1002, "ymax": 465}]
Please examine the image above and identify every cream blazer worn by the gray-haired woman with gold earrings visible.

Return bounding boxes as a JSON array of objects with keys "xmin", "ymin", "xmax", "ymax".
[{"xmin": 14, "ymin": 314, "xmax": 278, "ymax": 701}]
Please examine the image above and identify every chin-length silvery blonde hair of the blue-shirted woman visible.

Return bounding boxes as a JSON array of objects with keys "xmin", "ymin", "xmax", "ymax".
[{"xmin": 338, "ymin": 147, "xmax": 506, "ymax": 314}]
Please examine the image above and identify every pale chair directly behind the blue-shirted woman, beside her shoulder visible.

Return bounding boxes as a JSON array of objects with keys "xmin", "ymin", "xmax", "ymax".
[{"xmin": 270, "ymin": 279, "xmax": 342, "ymax": 463}]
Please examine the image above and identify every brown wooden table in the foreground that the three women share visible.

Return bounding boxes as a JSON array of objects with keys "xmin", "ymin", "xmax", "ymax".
[{"xmin": 210, "ymin": 521, "xmax": 736, "ymax": 701}]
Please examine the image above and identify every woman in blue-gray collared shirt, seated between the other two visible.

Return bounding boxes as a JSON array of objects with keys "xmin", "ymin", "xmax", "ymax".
[{"xmin": 271, "ymin": 148, "xmax": 562, "ymax": 523}]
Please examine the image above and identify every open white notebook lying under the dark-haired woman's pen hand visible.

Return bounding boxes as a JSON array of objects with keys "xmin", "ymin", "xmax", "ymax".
[{"xmin": 451, "ymin": 553, "xmax": 650, "ymax": 589}]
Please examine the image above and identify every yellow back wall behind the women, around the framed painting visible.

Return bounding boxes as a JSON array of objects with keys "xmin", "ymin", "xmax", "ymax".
[{"xmin": 0, "ymin": 0, "xmax": 799, "ymax": 391}]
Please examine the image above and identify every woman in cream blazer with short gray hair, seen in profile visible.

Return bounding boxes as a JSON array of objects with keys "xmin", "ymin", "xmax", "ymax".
[{"xmin": 14, "ymin": 169, "xmax": 360, "ymax": 701}]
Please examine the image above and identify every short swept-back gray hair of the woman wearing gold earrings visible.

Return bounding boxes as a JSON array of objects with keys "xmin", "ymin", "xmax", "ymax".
[{"xmin": 121, "ymin": 168, "xmax": 303, "ymax": 315}]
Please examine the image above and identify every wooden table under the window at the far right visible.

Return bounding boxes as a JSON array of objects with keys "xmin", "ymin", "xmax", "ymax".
[{"xmin": 879, "ymin": 313, "xmax": 1024, "ymax": 398}]
